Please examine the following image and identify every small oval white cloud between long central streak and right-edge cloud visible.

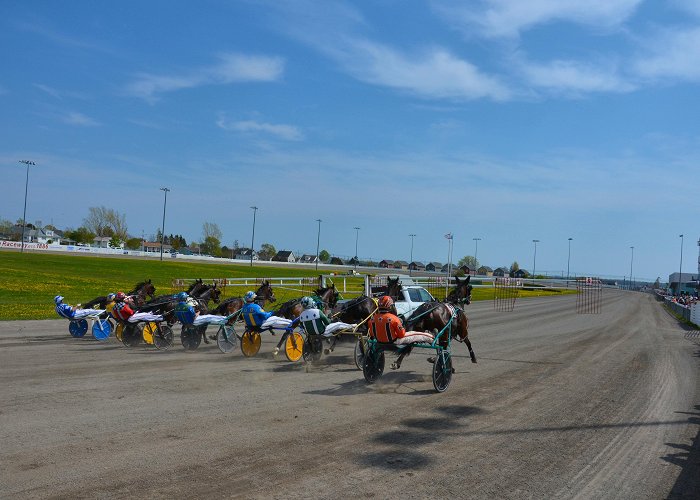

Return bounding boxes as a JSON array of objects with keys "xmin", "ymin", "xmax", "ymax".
[{"xmin": 521, "ymin": 60, "xmax": 635, "ymax": 95}]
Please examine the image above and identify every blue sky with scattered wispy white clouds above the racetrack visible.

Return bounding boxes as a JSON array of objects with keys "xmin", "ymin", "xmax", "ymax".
[{"xmin": 0, "ymin": 0, "xmax": 700, "ymax": 281}]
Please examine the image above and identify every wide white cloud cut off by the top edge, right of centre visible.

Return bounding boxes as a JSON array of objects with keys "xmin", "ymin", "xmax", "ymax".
[{"xmin": 433, "ymin": 0, "xmax": 643, "ymax": 37}]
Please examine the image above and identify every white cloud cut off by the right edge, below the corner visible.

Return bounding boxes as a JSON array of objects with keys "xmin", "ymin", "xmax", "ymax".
[{"xmin": 634, "ymin": 28, "xmax": 700, "ymax": 82}]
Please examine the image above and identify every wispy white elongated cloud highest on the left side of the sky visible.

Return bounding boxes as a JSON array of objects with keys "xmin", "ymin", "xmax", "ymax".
[{"xmin": 126, "ymin": 54, "xmax": 284, "ymax": 101}]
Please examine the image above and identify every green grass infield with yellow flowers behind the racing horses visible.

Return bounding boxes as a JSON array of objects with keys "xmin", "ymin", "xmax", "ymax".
[{"xmin": 0, "ymin": 251, "xmax": 573, "ymax": 320}]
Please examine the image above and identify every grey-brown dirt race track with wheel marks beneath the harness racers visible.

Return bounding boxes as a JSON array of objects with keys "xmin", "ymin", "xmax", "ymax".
[{"xmin": 0, "ymin": 290, "xmax": 700, "ymax": 499}]
